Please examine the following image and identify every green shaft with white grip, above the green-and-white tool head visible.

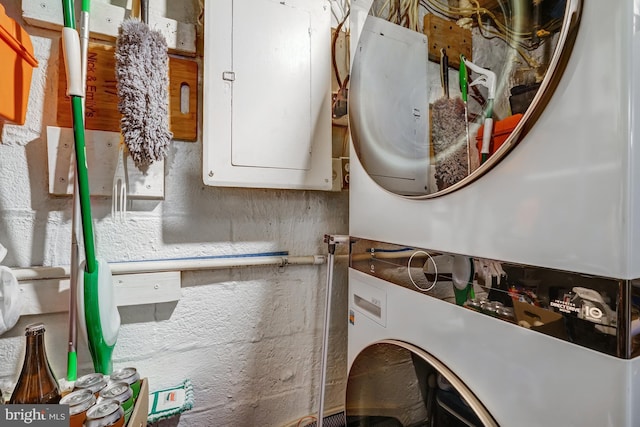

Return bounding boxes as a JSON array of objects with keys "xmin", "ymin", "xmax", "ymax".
[{"xmin": 62, "ymin": 0, "xmax": 97, "ymax": 273}]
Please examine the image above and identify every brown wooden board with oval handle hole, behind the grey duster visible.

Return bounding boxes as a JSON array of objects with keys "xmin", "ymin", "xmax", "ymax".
[{"xmin": 56, "ymin": 43, "xmax": 198, "ymax": 141}]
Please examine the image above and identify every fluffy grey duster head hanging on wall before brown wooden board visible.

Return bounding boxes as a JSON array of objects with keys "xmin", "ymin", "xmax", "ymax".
[{"xmin": 115, "ymin": 19, "xmax": 173, "ymax": 168}]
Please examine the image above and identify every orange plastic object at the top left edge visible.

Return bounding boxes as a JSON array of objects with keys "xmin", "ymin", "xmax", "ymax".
[{"xmin": 0, "ymin": 4, "xmax": 38, "ymax": 124}]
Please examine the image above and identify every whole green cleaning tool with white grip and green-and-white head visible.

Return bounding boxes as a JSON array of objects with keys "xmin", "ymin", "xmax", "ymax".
[{"xmin": 62, "ymin": 0, "xmax": 120, "ymax": 374}]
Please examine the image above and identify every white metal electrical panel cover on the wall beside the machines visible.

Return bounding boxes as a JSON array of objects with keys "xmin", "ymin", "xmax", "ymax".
[{"xmin": 203, "ymin": 0, "xmax": 332, "ymax": 190}]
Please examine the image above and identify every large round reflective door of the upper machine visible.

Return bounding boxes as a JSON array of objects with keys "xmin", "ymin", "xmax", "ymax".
[{"xmin": 349, "ymin": 0, "xmax": 581, "ymax": 198}]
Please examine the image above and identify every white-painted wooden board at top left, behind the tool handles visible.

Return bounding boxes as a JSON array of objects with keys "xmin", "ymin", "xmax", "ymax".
[{"xmin": 22, "ymin": 0, "xmax": 197, "ymax": 56}]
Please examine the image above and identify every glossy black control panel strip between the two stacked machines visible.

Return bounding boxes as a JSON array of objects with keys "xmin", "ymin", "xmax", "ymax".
[{"xmin": 349, "ymin": 237, "xmax": 640, "ymax": 359}]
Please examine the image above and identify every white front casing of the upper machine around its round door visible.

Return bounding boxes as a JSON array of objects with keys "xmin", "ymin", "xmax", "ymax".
[{"xmin": 350, "ymin": 0, "xmax": 640, "ymax": 279}]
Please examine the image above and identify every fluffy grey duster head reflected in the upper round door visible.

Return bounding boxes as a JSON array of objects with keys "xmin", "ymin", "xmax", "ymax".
[{"xmin": 431, "ymin": 98, "xmax": 469, "ymax": 190}]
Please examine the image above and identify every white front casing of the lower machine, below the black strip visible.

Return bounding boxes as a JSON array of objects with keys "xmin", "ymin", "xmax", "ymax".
[{"xmin": 347, "ymin": 269, "xmax": 640, "ymax": 427}]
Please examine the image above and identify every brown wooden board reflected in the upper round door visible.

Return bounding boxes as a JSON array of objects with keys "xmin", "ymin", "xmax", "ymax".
[{"xmin": 423, "ymin": 13, "xmax": 473, "ymax": 69}]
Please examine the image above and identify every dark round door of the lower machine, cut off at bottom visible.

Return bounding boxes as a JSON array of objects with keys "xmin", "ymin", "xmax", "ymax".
[{"xmin": 345, "ymin": 340, "xmax": 498, "ymax": 427}]
